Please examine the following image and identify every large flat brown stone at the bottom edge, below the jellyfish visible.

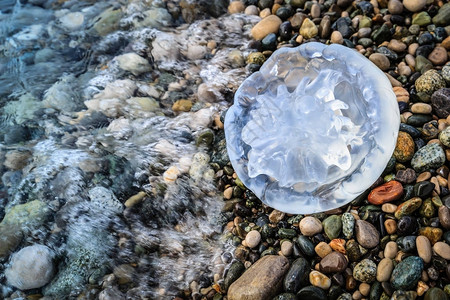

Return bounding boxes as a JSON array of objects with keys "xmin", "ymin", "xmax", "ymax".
[{"xmin": 228, "ymin": 255, "xmax": 289, "ymax": 300}]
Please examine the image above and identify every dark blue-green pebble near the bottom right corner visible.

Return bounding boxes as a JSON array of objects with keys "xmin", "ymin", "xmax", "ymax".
[{"xmin": 391, "ymin": 256, "xmax": 423, "ymax": 290}]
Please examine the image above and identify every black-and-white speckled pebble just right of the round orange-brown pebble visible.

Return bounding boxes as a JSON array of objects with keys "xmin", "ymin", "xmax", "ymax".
[{"xmin": 411, "ymin": 143, "xmax": 445, "ymax": 173}]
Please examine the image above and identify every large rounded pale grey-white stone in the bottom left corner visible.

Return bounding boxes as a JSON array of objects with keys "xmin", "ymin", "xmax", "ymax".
[{"xmin": 5, "ymin": 245, "xmax": 54, "ymax": 290}]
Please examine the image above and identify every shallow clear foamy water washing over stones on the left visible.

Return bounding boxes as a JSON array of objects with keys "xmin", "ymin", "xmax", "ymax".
[{"xmin": 0, "ymin": 0, "xmax": 255, "ymax": 299}]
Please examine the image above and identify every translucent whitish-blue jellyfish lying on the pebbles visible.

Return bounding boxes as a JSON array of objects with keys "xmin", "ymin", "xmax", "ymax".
[{"xmin": 225, "ymin": 43, "xmax": 400, "ymax": 214}]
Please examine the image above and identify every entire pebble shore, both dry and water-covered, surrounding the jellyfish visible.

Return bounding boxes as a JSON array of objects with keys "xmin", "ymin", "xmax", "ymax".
[{"xmin": 0, "ymin": 0, "xmax": 450, "ymax": 300}]
